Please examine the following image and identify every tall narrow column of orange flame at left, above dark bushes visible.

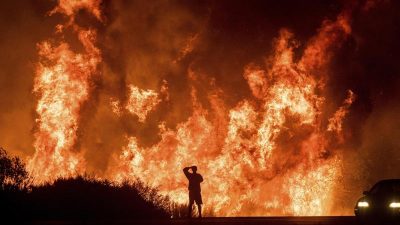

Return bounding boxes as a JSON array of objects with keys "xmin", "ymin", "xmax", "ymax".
[{"xmin": 28, "ymin": 1, "xmax": 101, "ymax": 183}]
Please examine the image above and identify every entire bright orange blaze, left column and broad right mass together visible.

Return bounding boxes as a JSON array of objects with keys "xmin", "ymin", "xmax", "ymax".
[{"xmin": 28, "ymin": 1, "xmax": 356, "ymax": 216}]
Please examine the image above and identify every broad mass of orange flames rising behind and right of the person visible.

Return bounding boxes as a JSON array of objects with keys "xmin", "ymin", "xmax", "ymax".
[{"xmin": 109, "ymin": 13, "xmax": 352, "ymax": 216}]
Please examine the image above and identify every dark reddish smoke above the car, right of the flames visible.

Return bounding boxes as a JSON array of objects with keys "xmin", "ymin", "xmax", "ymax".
[{"xmin": 327, "ymin": 1, "xmax": 400, "ymax": 214}]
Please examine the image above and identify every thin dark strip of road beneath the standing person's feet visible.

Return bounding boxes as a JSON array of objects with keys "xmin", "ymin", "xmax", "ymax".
[{"xmin": 24, "ymin": 216, "xmax": 357, "ymax": 225}]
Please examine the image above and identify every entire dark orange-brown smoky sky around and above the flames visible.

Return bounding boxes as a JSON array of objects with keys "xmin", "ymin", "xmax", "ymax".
[{"xmin": 0, "ymin": 0, "xmax": 400, "ymax": 212}]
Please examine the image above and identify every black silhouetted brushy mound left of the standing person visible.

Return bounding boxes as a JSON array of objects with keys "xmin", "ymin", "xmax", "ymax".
[{"xmin": 0, "ymin": 149, "xmax": 171, "ymax": 220}]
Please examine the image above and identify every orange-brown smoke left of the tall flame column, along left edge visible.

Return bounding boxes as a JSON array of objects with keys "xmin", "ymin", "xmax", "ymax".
[{"xmin": 0, "ymin": 1, "xmax": 55, "ymax": 158}]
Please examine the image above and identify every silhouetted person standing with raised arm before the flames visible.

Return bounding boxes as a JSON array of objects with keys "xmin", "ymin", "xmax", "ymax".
[{"xmin": 183, "ymin": 166, "xmax": 203, "ymax": 217}]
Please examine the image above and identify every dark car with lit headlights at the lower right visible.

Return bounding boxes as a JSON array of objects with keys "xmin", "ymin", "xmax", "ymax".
[{"xmin": 354, "ymin": 179, "xmax": 400, "ymax": 224}]
